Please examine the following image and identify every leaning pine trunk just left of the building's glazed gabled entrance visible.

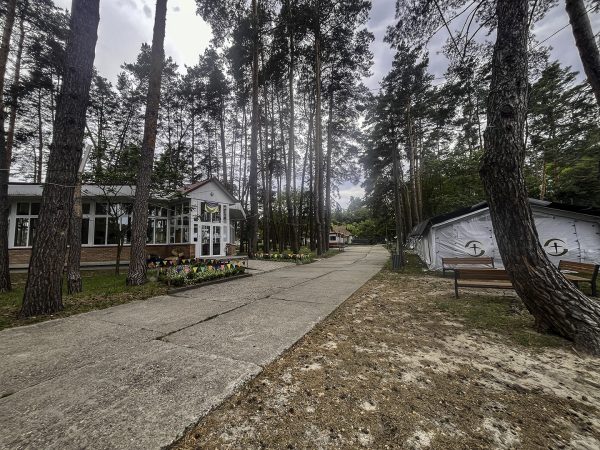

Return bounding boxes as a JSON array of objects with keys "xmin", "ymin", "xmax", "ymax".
[{"xmin": 127, "ymin": 0, "xmax": 167, "ymax": 286}]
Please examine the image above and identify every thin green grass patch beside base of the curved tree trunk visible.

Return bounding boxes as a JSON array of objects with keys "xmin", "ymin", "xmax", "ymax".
[{"xmin": 435, "ymin": 295, "xmax": 569, "ymax": 348}]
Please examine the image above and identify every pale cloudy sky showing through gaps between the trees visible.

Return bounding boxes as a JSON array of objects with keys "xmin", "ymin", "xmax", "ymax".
[{"xmin": 55, "ymin": 0, "xmax": 600, "ymax": 206}]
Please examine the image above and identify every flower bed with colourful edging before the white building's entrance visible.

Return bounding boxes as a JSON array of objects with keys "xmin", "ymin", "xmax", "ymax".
[{"xmin": 149, "ymin": 260, "xmax": 246, "ymax": 287}]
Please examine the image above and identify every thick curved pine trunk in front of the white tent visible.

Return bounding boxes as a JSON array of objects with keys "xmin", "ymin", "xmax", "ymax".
[{"xmin": 480, "ymin": 0, "xmax": 600, "ymax": 354}]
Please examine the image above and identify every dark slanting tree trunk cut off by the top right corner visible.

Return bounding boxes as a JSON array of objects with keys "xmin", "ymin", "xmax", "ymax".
[{"xmin": 566, "ymin": 0, "xmax": 600, "ymax": 105}]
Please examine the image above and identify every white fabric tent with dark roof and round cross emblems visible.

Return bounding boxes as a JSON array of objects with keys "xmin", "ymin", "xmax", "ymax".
[{"xmin": 409, "ymin": 199, "xmax": 600, "ymax": 270}]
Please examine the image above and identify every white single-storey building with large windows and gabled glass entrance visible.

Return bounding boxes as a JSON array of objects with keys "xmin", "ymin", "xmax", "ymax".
[{"xmin": 8, "ymin": 178, "xmax": 245, "ymax": 267}]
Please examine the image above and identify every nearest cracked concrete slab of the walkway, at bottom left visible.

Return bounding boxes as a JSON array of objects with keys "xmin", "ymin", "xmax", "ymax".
[{"xmin": 0, "ymin": 340, "xmax": 261, "ymax": 450}]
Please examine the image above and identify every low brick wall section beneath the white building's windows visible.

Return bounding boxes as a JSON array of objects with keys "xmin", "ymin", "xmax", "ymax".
[{"xmin": 8, "ymin": 244, "xmax": 195, "ymax": 268}]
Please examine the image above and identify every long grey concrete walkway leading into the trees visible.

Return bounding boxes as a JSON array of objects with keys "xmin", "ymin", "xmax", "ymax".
[{"xmin": 0, "ymin": 246, "xmax": 388, "ymax": 449}]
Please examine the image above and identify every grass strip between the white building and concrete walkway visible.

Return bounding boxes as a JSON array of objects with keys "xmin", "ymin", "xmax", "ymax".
[{"xmin": 0, "ymin": 269, "xmax": 167, "ymax": 330}]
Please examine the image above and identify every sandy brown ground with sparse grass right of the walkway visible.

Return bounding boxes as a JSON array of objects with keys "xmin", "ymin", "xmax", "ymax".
[{"xmin": 174, "ymin": 255, "xmax": 600, "ymax": 449}]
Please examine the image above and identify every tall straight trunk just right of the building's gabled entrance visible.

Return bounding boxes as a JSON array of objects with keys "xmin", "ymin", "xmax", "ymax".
[{"xmin": 248, "ymin": 0, "xmax": 259, "ymax": 258}]
